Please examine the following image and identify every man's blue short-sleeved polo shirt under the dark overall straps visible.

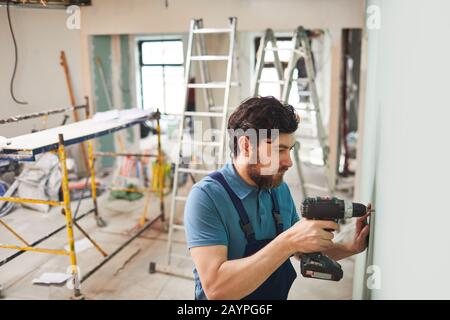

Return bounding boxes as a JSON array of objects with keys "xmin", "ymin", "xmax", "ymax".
[{"xmin": 184, "ymin": 161, "xmax": 299, "ymax": 260}]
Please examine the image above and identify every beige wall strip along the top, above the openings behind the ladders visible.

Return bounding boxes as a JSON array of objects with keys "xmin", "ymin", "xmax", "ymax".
[{"xmin": 82, "ymin": 0, "xmax": 364, "ymax": 34}]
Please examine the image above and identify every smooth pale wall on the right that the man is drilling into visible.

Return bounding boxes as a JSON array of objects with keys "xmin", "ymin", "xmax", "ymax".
[{"xmin": 358, "ymin": 0, "xmax": 450, "ymax": 299}]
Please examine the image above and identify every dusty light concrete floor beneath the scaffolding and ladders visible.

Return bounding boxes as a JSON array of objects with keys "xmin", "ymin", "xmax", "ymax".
[{"xmin": 0, "ymin": 156, "xmax": 353, "ymax": 300}]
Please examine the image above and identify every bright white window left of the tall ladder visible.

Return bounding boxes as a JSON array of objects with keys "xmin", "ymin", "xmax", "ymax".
[{"xmin": 139, "ymin": 39, "xmax": 184, "ymax": 114}]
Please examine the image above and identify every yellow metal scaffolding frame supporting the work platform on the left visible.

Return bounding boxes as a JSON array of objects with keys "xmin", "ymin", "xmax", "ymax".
[{"xmin": 0, "ymin": 98, "xmax": 164, "ymax": 299}]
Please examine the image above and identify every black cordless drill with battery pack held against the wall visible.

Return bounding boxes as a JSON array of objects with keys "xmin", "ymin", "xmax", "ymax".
[{"xmin": 300, "ymin": 197, "xmax": 367, "ymax": 281}]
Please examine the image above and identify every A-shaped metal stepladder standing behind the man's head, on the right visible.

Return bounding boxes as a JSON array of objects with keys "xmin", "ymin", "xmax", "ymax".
[{"xmin": 253, "ymin": 26, "xmax": 334, "ymax": 197}]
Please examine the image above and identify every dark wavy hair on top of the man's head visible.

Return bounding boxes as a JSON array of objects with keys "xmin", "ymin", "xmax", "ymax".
[{"xmin": 228, "ymin": 96, "xmax": 299, "ymax": 156}]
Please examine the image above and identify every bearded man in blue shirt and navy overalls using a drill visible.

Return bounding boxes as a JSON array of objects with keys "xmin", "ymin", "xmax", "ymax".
[{"xmin": 184, "ymin": 97, "xmax": 368, "ymax": 300}]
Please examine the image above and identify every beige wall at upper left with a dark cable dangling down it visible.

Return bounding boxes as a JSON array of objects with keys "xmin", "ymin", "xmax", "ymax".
[{"xmin": 0, "ymin": 8, "xmax": 84, "ymax": 137}]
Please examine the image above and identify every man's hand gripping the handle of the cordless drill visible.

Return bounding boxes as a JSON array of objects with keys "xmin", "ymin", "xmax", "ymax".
[{"xmin": 285, "ymin": 218, "xmax": 339, "ymax": 254}]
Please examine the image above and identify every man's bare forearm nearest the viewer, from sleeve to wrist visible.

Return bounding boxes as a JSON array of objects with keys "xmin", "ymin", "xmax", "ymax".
[{"xmin": 207, "ymin": 234, "xmax": 291, "ymax": 300}]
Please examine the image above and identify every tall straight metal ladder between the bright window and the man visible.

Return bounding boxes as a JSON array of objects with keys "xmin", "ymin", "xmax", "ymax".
[{"xmin": 149, "ymin": 17, "xmax": 238, "ymax": 279}]
